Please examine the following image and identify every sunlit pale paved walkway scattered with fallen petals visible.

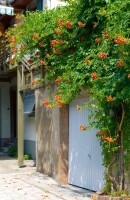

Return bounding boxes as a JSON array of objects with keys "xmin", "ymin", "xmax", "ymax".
[{"xmin": 0, "ymin": 156, "xmax": 91, "ymax": 200}]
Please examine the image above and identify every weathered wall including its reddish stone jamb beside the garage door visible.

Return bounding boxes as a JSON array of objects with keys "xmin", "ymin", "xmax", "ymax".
[{"xmin": 35, "ymin": 86, "xmax": 68, "ymax": 182}]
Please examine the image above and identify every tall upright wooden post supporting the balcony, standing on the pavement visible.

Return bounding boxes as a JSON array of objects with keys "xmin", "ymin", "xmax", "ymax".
[{"xmin": 17, "ymin": 66, "xmax": 24, "ymax": 167}]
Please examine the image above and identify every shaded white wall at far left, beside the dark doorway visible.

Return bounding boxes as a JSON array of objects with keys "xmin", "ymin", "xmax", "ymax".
[{"xmin": 0, "ymin": 82, "xmax": 10, "ymax": 138}]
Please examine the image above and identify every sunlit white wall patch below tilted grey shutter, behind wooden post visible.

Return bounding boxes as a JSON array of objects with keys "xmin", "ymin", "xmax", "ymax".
[{"xmin": 24, "ymin": 114, "xmax": 36, "ymax": 141}]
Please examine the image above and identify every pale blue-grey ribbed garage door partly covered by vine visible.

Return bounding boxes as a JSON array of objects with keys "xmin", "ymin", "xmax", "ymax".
[{"xmin": 68, "ymin": 98, "xmax": 104, "ymax": 191}]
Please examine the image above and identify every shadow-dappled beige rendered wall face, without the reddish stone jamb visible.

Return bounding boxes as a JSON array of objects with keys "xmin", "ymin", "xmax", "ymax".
[{"xmin": 35, "ymin": 88, "xmax": 60, "ymax": 180}]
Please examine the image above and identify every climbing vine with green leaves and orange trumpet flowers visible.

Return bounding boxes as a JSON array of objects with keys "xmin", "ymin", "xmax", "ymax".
[{"xmin": 6, "ymin": 0, "xmax": 130, "ymax": 193}]
